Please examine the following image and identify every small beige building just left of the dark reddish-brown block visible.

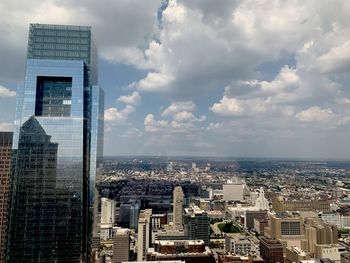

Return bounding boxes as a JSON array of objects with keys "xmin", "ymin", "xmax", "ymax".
[{"xmin": 225, "ymin": 234, "xmax": 252, "ymax": 255}]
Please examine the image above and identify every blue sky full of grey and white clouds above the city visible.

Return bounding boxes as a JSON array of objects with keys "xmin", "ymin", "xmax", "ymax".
[{"xmin": 0, "ymin": 0, "xmax": 350, "ymax": 159}]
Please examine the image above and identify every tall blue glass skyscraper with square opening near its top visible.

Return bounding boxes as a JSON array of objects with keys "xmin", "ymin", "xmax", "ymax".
[{"xmin": 5, "ymin": 24, "xmax": 104, "ymax": 262}]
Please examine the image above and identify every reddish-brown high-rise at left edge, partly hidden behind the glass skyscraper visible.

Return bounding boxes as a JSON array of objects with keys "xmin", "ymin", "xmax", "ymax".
[{"xmin": 0, "ymin": 132, "xmax": 13, "ymax": 262}]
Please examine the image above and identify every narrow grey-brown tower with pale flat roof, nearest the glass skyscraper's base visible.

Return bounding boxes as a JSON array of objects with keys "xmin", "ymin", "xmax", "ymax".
[{"xmin": 112, "ymin": 228, "xmax": 130, "ymax": 263}]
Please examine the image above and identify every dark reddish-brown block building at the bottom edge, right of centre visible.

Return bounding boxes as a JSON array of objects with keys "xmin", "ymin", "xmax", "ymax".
[{"xmin": 260, "ymin": 237, "xmax": 284, "ymax": 263}]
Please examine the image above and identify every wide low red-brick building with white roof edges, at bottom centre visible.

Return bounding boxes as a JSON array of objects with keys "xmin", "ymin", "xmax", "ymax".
[{"xmin": 147, "ymin": 240, "xmax": 215, "ymax": 263}]
